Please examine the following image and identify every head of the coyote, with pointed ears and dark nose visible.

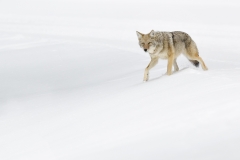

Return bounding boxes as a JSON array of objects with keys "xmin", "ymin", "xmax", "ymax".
[{"xmin": 137, "ymin": 30, "xmax": 156, "ymax": 52}]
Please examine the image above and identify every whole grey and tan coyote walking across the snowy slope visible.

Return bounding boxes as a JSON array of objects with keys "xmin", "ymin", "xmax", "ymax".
[{"xmin": 137, "ymin": 30, "xmax": 208, "ymax": 81}]
